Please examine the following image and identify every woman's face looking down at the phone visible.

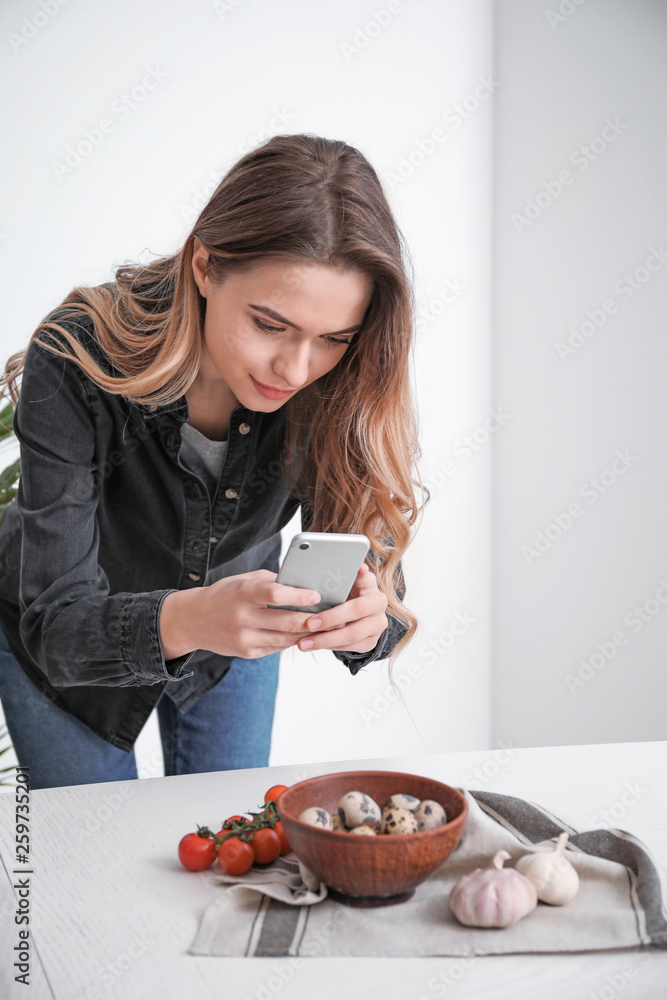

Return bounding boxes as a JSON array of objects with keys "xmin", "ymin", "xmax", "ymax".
[{"xmin": 192, "ymin": 238, "xmax": 373, "ymax": 412}]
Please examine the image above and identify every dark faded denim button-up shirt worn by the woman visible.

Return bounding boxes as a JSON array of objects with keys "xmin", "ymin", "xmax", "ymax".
[{"xmin": 0, "ymin": 309, "xmax": 407, "ymax": 750}]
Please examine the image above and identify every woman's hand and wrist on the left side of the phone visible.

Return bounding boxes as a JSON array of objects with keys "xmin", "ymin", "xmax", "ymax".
[{"xmin": 160, "ymin": 569, "xmax": 342, "ymax": 660}]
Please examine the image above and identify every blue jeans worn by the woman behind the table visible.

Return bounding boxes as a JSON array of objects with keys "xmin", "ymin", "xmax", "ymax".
[{"xmin": 0, "ymin": 628, "xmax": 280, "ymax": 788}]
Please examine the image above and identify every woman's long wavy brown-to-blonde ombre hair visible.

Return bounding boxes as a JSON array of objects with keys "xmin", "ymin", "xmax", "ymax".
[{"xmin": 0, "ymin": 133, "xmax": 430, "ymax": 678}]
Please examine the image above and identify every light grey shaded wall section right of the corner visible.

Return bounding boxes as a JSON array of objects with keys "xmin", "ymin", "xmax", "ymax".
[{"xmin": 493, "ymin": 0, "xmax": 667, "ymax": 746}]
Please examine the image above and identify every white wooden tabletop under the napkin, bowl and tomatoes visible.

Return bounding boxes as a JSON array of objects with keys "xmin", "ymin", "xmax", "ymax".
[{"xmin": 0, "ymin": 742, "xmax": 667, "ymax": 1000}]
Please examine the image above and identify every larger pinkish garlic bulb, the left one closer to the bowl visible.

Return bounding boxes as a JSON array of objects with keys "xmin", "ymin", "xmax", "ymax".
[{"xmin": 449, "ymin": 851, "xmax": 537, "ymax": 927}]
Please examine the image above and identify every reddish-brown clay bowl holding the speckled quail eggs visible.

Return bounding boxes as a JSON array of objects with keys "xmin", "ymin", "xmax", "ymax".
[{"xmin": 276, "ymin": 771, "xmax": 468, "ymax": 906}]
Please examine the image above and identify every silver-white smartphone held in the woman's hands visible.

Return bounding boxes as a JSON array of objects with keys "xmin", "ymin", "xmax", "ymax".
[{"xmin": 267, "ymin": 531, "xmax": 371, "ymax": 614}]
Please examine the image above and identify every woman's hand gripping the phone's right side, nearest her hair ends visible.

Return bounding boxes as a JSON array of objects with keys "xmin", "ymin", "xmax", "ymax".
[{"xmin": 297, "ymin": 563, "xmax": 389, "ymax": 653}]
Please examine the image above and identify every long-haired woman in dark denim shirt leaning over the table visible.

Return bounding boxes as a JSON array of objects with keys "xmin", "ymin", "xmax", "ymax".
[{"xmin": 0, "ymin": 134, "xmax": 428, "ymax": 787}]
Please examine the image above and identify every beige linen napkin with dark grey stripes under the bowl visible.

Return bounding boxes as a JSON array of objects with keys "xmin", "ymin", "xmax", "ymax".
[{"xmin": 189, "ymin": 789, "xmax": 667, "ymax": 958}]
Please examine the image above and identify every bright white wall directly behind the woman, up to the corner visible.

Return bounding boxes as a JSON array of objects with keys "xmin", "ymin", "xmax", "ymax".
[{"xmin": 0, "ymin": 0, "xmax": 496, "ymax": 774}]
